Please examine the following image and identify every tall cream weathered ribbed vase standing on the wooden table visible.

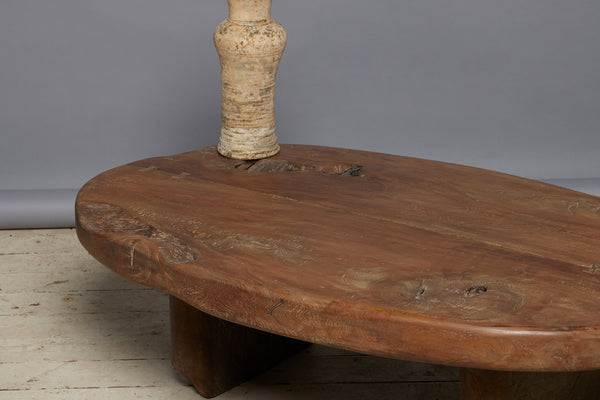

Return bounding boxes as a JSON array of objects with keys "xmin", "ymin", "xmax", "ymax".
[{"xmin": 214, "ymin": 0, "xmax": 287, "ymax": 160}]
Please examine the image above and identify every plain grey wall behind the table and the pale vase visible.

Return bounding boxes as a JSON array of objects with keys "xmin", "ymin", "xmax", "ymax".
[{"xmin": 0, "ymin": 0, "xmax": 600, "ymax": 225}]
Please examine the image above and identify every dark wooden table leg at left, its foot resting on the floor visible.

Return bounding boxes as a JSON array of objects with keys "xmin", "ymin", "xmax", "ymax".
[{"xmin": 170, "ymin": 296, "xmax": 308, "ymax": 398}]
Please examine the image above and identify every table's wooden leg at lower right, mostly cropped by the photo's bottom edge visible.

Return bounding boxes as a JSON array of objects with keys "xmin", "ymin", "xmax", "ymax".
[{"xmin": 460, "ymin": 368, "xmax": 600, "ymax": 400}]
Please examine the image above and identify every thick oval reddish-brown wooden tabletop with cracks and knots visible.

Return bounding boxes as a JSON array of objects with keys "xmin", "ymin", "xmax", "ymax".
[{"xmin": 76, "ymin": 145, "xmax": 600, "ymax": 371}]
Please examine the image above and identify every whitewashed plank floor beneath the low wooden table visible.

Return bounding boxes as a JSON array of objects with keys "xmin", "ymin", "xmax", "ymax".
[{"xmin": 0, "ymin": 229, "xmax": 459, "ymax": 400}]
